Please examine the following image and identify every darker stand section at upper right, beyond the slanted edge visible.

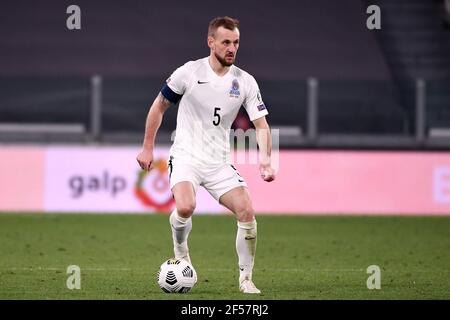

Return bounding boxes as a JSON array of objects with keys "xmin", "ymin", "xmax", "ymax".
[{"xmin": 370, "ymin": 0, "xmax": 450, "ymax": 139}]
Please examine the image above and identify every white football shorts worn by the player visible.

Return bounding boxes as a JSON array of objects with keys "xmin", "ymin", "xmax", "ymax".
[{"xmin": 168, "ymin": 156, "xmax": 247, "ymax": 201}]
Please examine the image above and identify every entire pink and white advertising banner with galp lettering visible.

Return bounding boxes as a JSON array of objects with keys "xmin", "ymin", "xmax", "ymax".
[{"xmin": 0, "ymin": 146, "xmax": 450, "ymax": 215}]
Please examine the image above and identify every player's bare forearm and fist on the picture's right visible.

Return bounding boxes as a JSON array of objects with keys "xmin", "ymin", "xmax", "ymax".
[{"xmin": 253, "ymin": 117, "xmax": 275, "ymax": 182}]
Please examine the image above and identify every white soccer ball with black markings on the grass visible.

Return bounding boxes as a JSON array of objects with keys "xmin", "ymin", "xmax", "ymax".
[{"xmin": 157, "ymin": 258, "xmax": 197, "ymax": 293}]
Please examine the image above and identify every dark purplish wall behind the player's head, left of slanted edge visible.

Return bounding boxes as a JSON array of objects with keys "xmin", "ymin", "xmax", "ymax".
[{"xmin": 0, "ymin": 0, "xmax": 389, "ymax": 80}]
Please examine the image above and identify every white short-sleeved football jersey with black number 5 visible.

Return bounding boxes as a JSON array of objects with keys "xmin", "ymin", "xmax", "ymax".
[{"xmin": 161, "ymin": 57, "xmax": 268, "ymax": 167}]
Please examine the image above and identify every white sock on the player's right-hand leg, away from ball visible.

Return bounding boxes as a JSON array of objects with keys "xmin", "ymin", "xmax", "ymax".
[{"xmin": 236, "ymin": 220, "xmax": 257, "ymax": 283}]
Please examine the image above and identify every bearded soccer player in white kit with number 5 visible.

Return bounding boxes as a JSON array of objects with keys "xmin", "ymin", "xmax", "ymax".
[{"xmin": 137, "ymin": 17, "xmax": 275, "ymax": 293}]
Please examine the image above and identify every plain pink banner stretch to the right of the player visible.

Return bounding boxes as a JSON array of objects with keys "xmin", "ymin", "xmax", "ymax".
[{"xmin": 236, "ymin": 151, "xmax": 450, "ymax": 215}]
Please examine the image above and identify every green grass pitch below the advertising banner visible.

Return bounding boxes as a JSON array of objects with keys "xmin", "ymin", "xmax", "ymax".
[{"xmin": 0, "ymin": 214, "xmax": 450, "ymax": 300}]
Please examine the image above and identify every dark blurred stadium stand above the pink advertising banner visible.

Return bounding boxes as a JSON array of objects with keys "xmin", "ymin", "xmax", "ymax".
[{"xmin": 0, "ymin": 0, "xmax": 450, "ymax": 148}]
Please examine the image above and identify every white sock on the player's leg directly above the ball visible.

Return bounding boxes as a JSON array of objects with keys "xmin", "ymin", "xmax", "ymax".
[{"xmin": 169, "ymin": 209, "xmax": 192, "ymax": 263}]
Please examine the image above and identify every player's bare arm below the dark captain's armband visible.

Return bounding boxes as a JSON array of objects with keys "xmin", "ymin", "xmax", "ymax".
[{"xmin": 136, "ymin": 93, "xmax": 171, "ymax": 171}]
